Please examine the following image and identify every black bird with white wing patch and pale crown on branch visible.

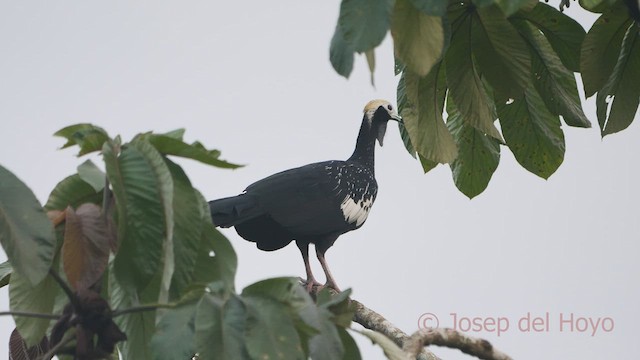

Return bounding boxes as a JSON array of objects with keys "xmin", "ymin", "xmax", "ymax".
[{"xmin": 209, "ymin": 100, "xmax": 402, "ymax": 292}]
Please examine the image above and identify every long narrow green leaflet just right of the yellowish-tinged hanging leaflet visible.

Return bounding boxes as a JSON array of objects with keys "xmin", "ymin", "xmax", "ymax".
[{"xmin": 445, "ymin": 10, "xmax": 503, "ymax": 142}]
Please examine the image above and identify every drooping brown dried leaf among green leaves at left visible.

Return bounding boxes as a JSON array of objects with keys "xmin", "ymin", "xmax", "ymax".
[{"xmin": 62, "ymin": 203, "xmax": 110, "ymax": 291}]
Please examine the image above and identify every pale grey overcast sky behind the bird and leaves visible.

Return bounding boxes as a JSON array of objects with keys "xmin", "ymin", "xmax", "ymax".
[{"xmin": 0, "ymin": 0, "xmax": 640, "ymax": 360}]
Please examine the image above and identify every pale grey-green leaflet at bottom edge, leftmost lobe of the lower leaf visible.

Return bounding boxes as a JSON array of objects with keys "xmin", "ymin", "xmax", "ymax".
[{"xmin": 151, "ymin": 301, "xmax": 198, "ymax": 360}]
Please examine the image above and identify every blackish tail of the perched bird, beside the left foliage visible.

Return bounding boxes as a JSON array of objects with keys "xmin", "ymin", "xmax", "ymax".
[{"xmin": 209, "ymin": 194, "xmax": 263, "ymax": 228}]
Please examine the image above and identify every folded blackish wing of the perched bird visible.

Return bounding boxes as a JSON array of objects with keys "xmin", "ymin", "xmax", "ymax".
[{"xmin": 246, "ymin": 161, "xmax": 355, "ymax": 237}]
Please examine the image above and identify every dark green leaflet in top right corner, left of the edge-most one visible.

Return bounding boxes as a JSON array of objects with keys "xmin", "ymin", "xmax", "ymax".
[{"xmin": 580, "ymin": 1, "xmax": 633, "ymax": 97}]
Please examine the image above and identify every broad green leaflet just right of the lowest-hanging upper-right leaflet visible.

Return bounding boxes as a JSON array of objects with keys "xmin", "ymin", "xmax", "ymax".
[{"xmin": 498, "ymin": 87, "xmax": 565, "ymax": 179}]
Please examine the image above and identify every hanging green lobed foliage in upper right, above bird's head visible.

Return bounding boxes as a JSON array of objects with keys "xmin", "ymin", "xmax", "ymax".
[{"xmin": 330, "ymin": 0, "xmax": 640, "ymax": 198}]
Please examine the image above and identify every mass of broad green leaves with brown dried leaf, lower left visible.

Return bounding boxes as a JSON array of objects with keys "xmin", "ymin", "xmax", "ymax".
[{"xmin": 0, "ymin": 129, "xmax": 376, "ymax": 360}]
